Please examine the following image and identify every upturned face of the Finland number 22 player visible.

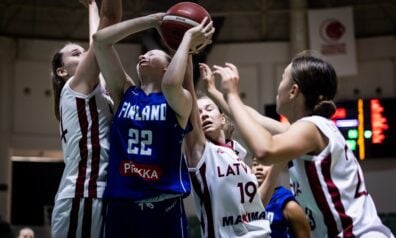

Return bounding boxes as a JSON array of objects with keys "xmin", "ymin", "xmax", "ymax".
[{"xmin": 136, "ymin": 50, "xmax": 170, "ymax": 74}]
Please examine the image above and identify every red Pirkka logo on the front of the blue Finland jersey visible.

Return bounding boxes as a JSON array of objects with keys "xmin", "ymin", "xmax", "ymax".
[{"xmin": 120, "ymin": 160, "xmax": 162, "ymax": 181}]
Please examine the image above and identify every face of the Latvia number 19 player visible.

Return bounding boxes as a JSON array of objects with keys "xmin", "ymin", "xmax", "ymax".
[{"xmin": 197, "ymin": 98, "xmax": 225, "ymax": 136}]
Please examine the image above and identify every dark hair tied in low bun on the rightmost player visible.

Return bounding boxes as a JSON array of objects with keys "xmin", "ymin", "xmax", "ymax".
[{"xmin": 291, "ymin": 52, "xmax": 337, "ymax": 118}]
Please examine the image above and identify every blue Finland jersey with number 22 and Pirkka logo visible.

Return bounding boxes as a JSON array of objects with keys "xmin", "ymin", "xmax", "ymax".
[{"xmin": 104, "ymin": 87, "xmax": 191, "ymax": 201}]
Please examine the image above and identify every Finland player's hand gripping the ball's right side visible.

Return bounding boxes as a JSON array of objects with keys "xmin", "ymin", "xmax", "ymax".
[{"xmin": 185, "ymin": 17, "xmax": 215, "ymax": 54}]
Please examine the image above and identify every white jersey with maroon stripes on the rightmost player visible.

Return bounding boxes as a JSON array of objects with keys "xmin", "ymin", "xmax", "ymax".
[{"xmin": 289, "ymin": 116, "xmax": 391, "ymax": 238}]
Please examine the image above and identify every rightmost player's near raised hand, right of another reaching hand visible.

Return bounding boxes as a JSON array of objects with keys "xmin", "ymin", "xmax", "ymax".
[{"xmin": 213, "ymin": 63, "xmax": 239, "ymax": 99}]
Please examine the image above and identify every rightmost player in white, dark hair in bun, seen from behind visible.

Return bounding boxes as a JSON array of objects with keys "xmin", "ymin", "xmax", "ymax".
[{"xmin": 214, "ymin": 53, "xmax": 393, "ymax": 237}]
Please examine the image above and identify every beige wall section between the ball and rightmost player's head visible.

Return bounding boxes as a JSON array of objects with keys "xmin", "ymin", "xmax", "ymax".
[{"xmin": 208, "ymin": 43, "xmax": 289, "ymax": 108}]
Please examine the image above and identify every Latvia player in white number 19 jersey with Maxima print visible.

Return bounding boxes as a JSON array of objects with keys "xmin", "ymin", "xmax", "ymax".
[{"xmin": 184, "ymin": 61, "xmax": 270, "ymax": 237}]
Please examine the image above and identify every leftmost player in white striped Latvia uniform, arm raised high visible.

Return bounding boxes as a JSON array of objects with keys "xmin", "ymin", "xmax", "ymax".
[{"xmin": 51, "ymin": 0, "xmax": 122, "ymax": 238}]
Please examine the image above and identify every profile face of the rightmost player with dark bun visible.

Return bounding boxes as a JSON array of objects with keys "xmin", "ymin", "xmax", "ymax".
[{"xmin": 276, "ymin": 64, "xmax": 293, "ymax": 115}]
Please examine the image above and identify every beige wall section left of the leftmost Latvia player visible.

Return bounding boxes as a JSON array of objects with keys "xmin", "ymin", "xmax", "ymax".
[{"xmin": 12, "ymin": 40, "xmax": 63, "ymax": 149}]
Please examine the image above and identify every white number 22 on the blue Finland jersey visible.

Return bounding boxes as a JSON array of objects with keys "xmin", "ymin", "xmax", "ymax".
[{"xmin": 128, "ymin": 128, "xmax": 153, "ymax": 155}]
